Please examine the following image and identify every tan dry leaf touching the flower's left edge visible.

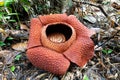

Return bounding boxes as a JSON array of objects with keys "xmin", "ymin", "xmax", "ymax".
[{"xmin": 12, "ymin": 41, "xmax": 27, "ymax": 52}]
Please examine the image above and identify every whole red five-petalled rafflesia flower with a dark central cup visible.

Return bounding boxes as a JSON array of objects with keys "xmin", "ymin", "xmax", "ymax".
[{"xmin": 27, "ymin": 14, "xmax": 94, "ymax": 75}]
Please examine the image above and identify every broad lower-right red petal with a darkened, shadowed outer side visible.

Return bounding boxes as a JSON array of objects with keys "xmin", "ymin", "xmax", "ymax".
[{"xmin": 63, "ymin": 36, "xmax": 94, "ymax": 67}]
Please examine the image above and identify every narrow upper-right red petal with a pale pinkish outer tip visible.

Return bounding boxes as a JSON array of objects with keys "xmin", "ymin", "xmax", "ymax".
[{"xmin": 66, "ymin": 15, "xmax": 95, "ymax": 37}]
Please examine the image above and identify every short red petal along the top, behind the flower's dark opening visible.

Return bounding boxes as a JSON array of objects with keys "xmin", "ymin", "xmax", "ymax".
[{"xmin": 39, "ymin": 14, "xmax": 67, "ymax": 25}]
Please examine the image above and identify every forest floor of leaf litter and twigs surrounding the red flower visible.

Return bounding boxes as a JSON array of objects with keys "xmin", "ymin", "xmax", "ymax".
[{"xmin": 0, "ymin": 0, "xmax": 120, "ymax": 80}]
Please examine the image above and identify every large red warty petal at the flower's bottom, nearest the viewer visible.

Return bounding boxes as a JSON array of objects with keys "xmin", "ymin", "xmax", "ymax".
[{"xmin": 27, "ymin": 47, "xmax": 70, "ymax": 75}]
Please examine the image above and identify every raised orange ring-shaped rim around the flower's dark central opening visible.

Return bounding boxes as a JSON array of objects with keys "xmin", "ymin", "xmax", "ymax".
[{"xmin": 41, "ymin": 22, "xmax": 76, "ymax": 53}]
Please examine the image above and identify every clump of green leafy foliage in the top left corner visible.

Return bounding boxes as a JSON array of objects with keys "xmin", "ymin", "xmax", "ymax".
[{"xmin": 0, "ymin": 0, "xmax": 31, "ymax": 29}]
